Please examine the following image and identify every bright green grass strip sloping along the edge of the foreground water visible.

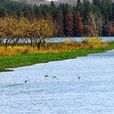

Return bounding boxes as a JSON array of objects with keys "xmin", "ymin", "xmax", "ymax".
[{"xmin": 0, "ymin": 42, "xmax": 114, "ymax": 72}]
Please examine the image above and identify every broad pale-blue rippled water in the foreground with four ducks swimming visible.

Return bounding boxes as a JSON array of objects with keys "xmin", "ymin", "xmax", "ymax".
[{"xmin": 0, "ymin": 50, "xmax": 114, "ymax": 114}]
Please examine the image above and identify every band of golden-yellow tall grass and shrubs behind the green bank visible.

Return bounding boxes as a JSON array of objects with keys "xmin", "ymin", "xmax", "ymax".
[{"xmin": 0, "ymin": 38, "xmax": 108, "ymax": 57}]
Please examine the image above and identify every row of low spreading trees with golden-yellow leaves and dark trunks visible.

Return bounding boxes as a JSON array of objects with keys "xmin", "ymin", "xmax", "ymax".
[{"xmin": 0, "ymin": 17, "xmax": 54, "ymax": 49}]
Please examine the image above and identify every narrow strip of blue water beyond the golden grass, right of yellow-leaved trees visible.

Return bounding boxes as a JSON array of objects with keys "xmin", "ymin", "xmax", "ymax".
[{"xmin": 47, "ymin": 37, "xmax": 114, "ymax": 42}]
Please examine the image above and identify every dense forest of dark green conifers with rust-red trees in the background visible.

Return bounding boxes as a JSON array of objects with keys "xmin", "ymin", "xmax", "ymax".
[{"xmin": 0, "ymin": 0, "xmax": 114, "ymax": 37}]
